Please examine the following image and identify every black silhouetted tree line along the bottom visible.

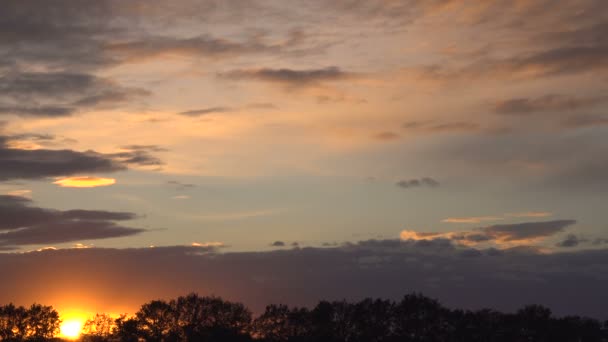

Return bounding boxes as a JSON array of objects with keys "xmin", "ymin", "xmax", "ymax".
[{"xmin": 0, "ymin": 293, "xmax": 608, "ymax": 342}]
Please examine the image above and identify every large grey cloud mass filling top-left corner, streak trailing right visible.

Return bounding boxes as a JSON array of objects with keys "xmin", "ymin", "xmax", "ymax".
[{"xmin": 0, "ymin": 0, "xmax": 319, "ymax": 117}]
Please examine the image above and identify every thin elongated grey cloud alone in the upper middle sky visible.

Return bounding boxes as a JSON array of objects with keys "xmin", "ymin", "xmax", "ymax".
[{"xmin": 219, "ymin": 66, "xmax": 354, "ymax": 86}]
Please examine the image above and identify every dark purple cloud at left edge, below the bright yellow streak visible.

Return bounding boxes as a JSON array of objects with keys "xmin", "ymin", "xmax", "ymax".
[{"xmin": 0, "ymin": 195, "xmax": 144, "ymax": 249}]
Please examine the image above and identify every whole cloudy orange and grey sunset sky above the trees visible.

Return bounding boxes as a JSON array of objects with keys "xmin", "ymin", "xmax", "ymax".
[{"xmin": 0, "ymin": 0, "xmax": 608, "ymax": 318}]
